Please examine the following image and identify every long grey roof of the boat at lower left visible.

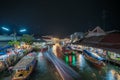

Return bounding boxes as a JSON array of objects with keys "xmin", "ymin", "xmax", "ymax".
[{"xmin": 13, "ymin": 56, "xmax": 35, "ymax": 70}]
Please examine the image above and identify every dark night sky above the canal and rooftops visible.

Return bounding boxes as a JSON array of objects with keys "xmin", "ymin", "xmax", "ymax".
[{"xmin": 0, "ymin": 0, "xmax": 120, "ymax": 36}]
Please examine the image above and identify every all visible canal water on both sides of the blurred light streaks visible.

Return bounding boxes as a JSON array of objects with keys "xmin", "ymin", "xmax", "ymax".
[{"xmin": 0, "ymin": 53, "xmax": 120, "ymax": 80}]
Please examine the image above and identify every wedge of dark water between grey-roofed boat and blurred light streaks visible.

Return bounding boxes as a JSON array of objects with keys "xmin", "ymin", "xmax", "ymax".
[{"xmin": 29, "ymin": 53, "xmax": 54, "ymax": 80}]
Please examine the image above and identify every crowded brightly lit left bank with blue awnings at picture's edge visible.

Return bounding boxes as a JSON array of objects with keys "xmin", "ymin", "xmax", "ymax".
[{"xmin": 0, "ymin": 45, "xmax": 25, "ymax": 72}]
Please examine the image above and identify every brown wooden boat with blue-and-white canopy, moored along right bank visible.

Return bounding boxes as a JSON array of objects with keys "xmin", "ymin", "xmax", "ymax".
[{"xmin": 83, "ymin": 50, "xmax": 105, "ymax": 67}]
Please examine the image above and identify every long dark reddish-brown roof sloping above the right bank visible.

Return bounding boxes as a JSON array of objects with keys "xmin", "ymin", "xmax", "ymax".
[{"xmin": 75, "ymin": 33, "xmax": 120, "ymax": 53}]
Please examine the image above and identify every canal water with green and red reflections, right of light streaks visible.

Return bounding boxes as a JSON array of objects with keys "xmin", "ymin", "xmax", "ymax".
[{"xmin": 64, "ymin": 53, "xmax": 120, "ymax": 80}]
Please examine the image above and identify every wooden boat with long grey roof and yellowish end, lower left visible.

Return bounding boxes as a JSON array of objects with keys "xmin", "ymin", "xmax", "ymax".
[{"xmin": 12, "ymin": 53, "xmax": 36, "ymax": 80}]
